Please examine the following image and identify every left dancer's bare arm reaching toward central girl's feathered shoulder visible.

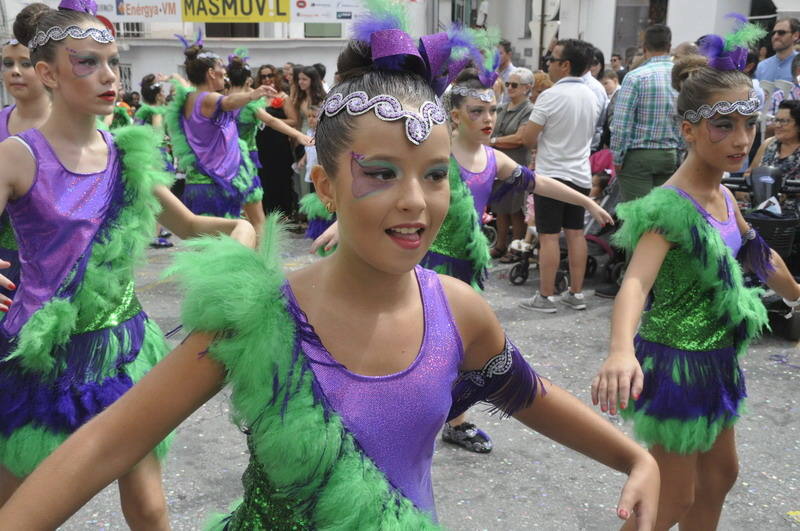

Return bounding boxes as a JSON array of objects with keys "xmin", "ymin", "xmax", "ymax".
[{"xmin": 154, "ymin": 186, "xmax": 256, "ymax": 248}]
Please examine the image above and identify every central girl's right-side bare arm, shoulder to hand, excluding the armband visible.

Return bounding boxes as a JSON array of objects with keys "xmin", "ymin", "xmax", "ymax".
[{"xmin": 440, "ymin": 276, "xmax": 660, "ymax": 530}]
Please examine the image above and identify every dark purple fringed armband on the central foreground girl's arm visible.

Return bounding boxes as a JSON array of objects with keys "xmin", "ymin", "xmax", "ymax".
[{"xmin": 447, "ymin": 338, "xmax": 546, "ymax": 420}]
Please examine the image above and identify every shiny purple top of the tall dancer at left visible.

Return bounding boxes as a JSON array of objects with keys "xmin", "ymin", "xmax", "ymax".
[{"xmin": 2, "ymin": 129, "xmax": 120, "ymax": 335}]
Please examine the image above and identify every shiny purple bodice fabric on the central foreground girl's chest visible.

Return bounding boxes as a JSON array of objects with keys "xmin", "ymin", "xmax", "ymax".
[{"xmin": 283, "ymin": 266, "xmax": 464, "ymax": 518}]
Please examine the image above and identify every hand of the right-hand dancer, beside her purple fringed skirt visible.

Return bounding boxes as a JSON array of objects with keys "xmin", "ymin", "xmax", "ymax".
[{"xmin": 592, "ymin": 349, "xmax": 644, "ymax": 415}]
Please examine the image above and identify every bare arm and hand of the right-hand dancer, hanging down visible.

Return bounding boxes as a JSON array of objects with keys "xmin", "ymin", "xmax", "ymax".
[{"xmin": 592, "ymin": 232, "xmax": 670, "ymax": 414}]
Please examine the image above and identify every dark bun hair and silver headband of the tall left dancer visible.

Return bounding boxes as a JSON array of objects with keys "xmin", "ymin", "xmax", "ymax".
[{"xmin": 13, "ymin": 0, "xmax": 103, "ymax": 65}]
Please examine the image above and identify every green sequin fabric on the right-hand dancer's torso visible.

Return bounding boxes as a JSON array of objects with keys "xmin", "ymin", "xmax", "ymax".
[{"xmin": 639, "ymin": 248, "xmax": 733, "ymax": 351}]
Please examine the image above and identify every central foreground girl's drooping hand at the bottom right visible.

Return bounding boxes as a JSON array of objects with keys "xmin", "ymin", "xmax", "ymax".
[{"xmin": 617, "ymin": 450, "xmax": 661, "ymax": 531}]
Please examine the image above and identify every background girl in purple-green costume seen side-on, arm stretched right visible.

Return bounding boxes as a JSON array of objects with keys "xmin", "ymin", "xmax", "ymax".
[{"xmin": 166, "ymin": 39, "xmax": 274, "ymax": 230}]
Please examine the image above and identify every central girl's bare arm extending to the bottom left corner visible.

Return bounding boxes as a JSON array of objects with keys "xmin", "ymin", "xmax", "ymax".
[{"xmin": 0, "ymin": 333, "xmax": 225, "ymax": 531}]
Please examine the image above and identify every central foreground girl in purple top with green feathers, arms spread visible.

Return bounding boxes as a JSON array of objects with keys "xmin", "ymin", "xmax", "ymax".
[{"xmin": 0, "ymin": 14, "xmax": 658, "ymax": 531}]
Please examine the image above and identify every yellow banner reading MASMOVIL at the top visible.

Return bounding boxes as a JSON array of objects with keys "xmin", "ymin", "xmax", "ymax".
[{"xmin": 181, "ymin": 0, "xmax": 290, "ymax": 22}]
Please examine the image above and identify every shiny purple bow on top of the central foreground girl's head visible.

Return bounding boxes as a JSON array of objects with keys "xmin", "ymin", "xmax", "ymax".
[{"xmin": 370, "ymin": 29, "xmax": 476, "ymax": 96}]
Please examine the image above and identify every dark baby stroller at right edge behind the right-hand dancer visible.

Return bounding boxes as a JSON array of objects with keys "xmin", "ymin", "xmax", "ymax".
[{"xmin": 722, "ymin": 166, "xmax": 800, "ymax": 341}]
